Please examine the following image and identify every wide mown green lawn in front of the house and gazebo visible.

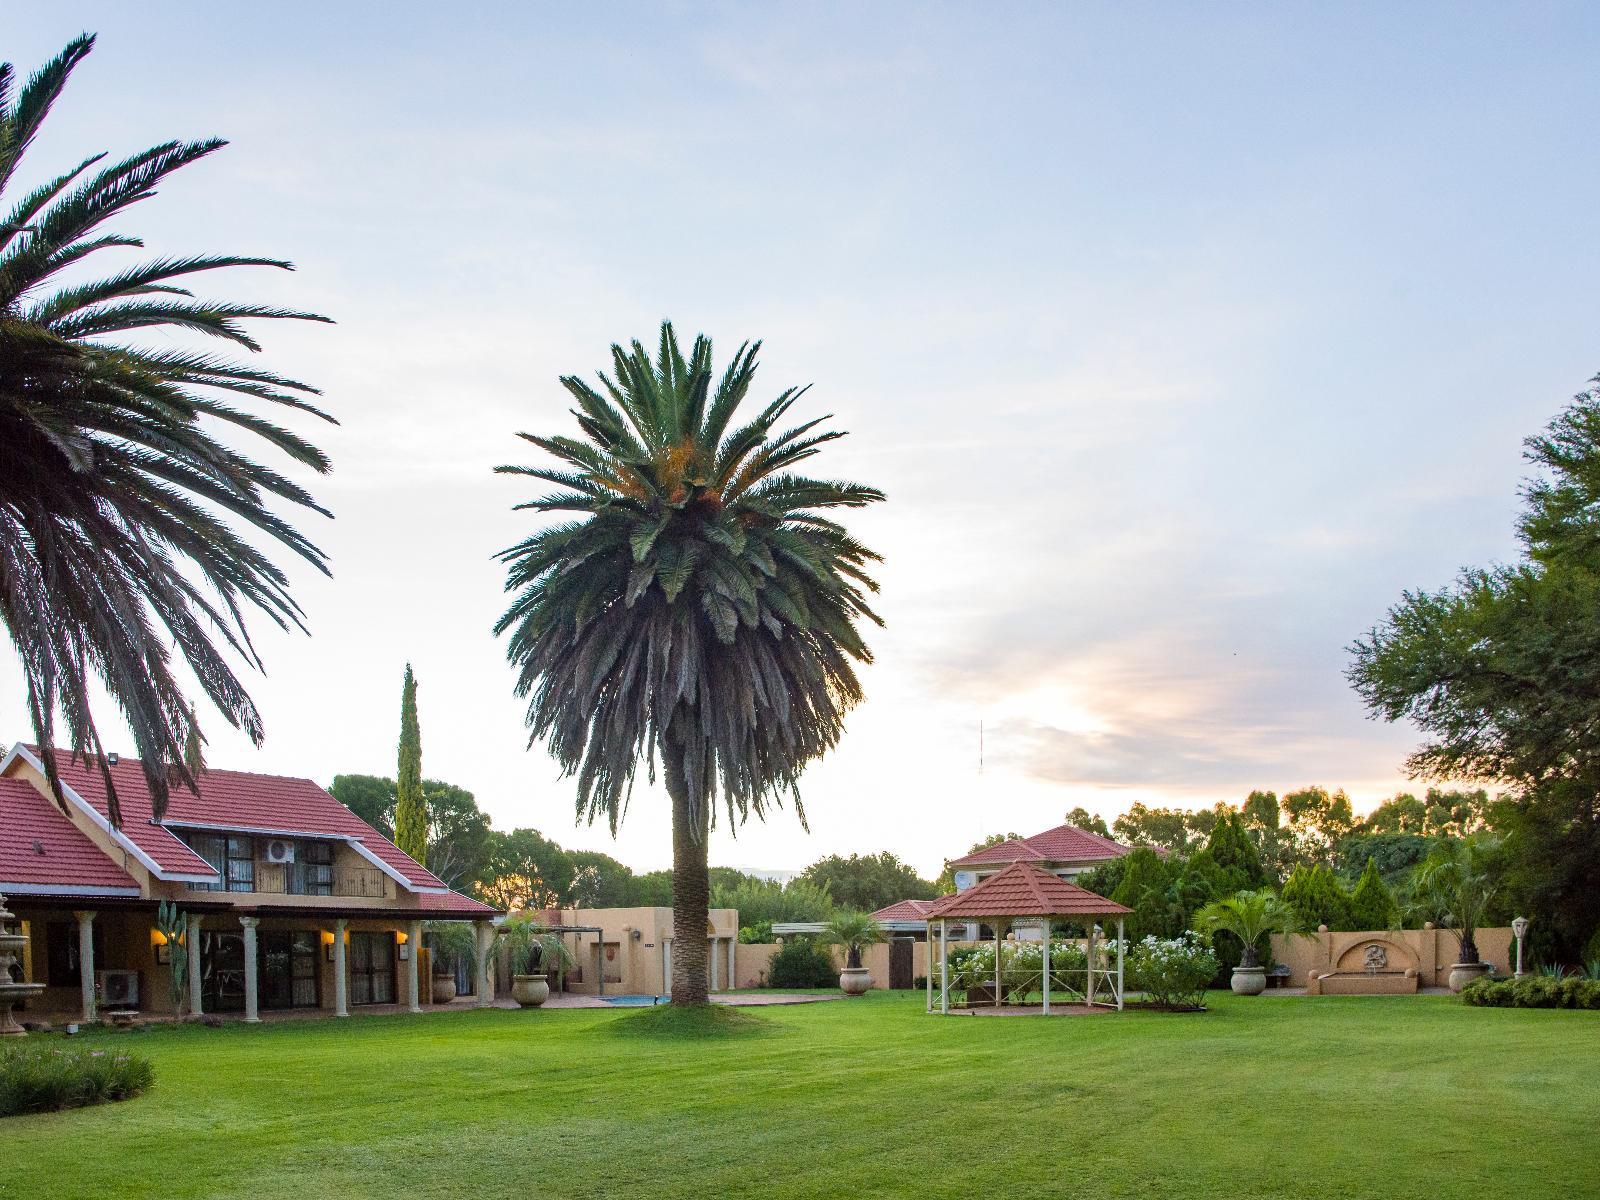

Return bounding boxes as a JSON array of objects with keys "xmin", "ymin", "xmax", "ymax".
[{"xmin": 0, "ymin": 994, "xmax": 1600, "ymax": 1200}]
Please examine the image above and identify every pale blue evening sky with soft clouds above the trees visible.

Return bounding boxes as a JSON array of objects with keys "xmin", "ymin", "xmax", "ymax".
[{"xmin": 0, "ymin": 3, "xmax": 1600, "ymax": 875}]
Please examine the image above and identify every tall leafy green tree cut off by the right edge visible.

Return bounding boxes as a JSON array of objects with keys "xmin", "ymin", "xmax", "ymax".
[{"xmin": 1349, "ymin": 378, "xmax": 1600, "ymax": 962}]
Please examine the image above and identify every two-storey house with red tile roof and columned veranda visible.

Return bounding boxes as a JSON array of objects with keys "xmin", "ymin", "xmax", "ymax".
[{"xmin": 0, "ymin": 744, "xmax": 499, "ymax": 1021}]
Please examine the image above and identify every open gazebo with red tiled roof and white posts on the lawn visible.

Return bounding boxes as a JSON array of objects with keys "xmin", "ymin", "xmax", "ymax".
[{"xmin": 928, "ymin": 862, "xmax": 1133, "ymax": 1016}]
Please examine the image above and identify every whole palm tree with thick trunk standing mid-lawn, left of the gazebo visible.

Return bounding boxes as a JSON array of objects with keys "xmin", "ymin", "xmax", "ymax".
[{"xmin": 496, "ymin": 323, "xmax": 883, "ymax": 1005}]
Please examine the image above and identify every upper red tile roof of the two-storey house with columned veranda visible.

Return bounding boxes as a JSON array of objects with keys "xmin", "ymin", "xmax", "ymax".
[{"xmin": 25, "ymin": 750, "xmax": 445, "ymax": 890}]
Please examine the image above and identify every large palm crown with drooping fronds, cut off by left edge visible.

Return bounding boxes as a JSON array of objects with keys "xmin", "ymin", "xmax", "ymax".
[{"xmin": 0, "ymin": 35, "xmax": 331, "ymax": 824}]
